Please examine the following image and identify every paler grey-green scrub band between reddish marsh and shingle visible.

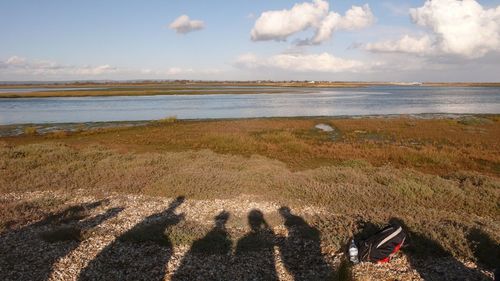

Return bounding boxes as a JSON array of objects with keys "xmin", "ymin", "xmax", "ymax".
[{"xmin": 0, "ymin": 141, "xmax": 500, "ymax": 262}]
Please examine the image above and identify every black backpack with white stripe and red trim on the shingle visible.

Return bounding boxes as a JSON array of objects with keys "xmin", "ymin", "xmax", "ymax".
[{"xmin": 358, "ymin": 224, "xmax": 406, "ymax": 263}]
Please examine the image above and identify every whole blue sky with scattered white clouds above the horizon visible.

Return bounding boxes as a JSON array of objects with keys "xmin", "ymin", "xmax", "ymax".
[{"xmin": 0, "ymin": 0, "xmax": 500, "ymax": 82}]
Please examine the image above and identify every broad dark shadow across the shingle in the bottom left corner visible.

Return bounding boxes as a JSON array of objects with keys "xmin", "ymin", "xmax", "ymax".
[{"xmin": 0, "ymin": 201, "xmax": 123, "ymax": 281}]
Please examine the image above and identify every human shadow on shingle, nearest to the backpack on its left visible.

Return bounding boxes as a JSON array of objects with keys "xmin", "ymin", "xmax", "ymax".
[{"xmin": 279, "ymin": 207, "xmax": 335, "ymax": 281}]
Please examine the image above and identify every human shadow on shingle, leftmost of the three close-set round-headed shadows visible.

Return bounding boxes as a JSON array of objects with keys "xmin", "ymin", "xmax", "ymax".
[{"xmin": 171, "ymin": 211, "xmax": 232, "ymax": 281}]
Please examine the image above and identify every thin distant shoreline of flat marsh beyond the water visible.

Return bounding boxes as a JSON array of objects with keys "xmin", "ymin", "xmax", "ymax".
[{"xmin": 0, "ymin": 81, "xmax": 500, "ymax": 98}]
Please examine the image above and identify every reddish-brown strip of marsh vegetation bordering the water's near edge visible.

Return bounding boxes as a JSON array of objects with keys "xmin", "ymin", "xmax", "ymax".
[{"xmin": 4, "ymin": 116, "xmax": 500, "ymax": 176}]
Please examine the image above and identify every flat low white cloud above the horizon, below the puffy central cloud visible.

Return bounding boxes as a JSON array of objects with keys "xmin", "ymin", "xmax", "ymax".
[{"xmin": 234, "ymin": 53, "xmax": 366, "ymax": 73}]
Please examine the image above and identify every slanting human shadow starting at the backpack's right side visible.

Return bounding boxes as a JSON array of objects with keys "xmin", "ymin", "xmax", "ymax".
[{"xmin": 360, "ymin": 218, "xmax": 488, "ymax": 281}]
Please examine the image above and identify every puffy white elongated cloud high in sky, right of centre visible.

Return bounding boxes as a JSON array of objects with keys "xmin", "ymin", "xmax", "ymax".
[{"xmin": 250, "ymin": 0, "xmax": 375, "ymax": 44}]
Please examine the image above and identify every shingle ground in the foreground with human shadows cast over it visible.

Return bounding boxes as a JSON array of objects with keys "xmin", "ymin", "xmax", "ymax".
[{"xmin": 0, "ymin": 192, "xmax": 492, "ymax": 280}]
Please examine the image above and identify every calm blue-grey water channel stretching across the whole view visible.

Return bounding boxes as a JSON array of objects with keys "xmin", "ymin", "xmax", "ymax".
[{"xmin": 0, "ymin": 87, "xmax": 500, "ymax": 125}]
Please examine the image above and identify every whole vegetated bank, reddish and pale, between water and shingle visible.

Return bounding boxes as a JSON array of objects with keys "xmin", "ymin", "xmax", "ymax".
[{"xmin": 0, "ymin": 116, "xmax": 500, "ymax": 272}]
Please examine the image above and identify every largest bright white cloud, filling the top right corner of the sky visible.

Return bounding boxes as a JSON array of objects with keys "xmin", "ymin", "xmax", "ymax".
[{"xmin": 365, "ymin": 0, "xmax": 500, "ymax": 58}]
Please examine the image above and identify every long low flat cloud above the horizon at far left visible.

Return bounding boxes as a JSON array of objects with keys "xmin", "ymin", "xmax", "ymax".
[{"xmin": 0, "ymin": 56, "xmax": 118, "ymax": 76}]
